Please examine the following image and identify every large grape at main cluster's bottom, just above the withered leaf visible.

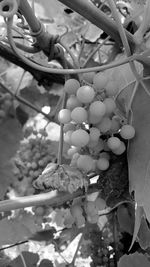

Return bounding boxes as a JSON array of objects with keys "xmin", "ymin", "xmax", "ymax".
[{"xmin": 77, "ymin": 155, "xmax": 93, "ymax": 172}]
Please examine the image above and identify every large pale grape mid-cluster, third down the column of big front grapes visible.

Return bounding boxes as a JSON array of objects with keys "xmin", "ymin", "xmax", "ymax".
[{"xmin": 71, "ymin": 129, "xmax": 90, "ymax": 147}]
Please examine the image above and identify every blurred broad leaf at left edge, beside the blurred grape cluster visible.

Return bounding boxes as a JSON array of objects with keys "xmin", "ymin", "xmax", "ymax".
[{"xmin": 0, "ymin": 118, "xmax": 22, "ymax": 198}]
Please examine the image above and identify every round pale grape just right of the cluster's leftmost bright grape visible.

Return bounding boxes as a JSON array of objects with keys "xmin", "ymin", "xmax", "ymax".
[{"xmin": 71, "ymin": 107, "xmax": 88, "ymax": 123}]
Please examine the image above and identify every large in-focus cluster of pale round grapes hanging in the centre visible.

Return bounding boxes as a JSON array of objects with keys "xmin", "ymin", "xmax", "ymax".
[{"xmin": 58, "ymin": 73, "xmax": 135, "ymax": 174}]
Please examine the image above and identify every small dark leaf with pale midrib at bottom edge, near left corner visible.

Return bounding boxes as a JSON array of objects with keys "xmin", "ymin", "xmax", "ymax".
[{"xmin": 11, "ymin": 251, "xmax": 39, "ymax": 267}]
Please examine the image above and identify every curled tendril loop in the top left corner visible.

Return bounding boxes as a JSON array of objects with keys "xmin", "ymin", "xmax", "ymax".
[{"xmin": 0, "ymin": 0, "xmax": 20, "ymax": 18}]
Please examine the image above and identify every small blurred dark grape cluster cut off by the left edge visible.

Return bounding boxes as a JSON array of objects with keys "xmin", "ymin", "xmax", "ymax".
[{"xmin": 0, "ymin": 92, "xmax": 13, "ymax": 123}]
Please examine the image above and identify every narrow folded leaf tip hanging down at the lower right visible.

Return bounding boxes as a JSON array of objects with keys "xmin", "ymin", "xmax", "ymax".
[{"xmin": 129, "ymin": 206, "xmax": 144, "ymax": 251}]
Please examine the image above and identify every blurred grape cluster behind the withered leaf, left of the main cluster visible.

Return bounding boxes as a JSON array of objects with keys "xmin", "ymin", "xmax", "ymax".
[{"xmin": 12, "ymin": 127, "xmax": 56, "ymax": 195}]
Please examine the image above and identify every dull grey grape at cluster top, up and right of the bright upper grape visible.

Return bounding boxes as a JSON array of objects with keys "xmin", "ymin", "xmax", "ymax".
[{"xmin": 93, "ymin": 72, "xmax": 108, "ymax": 91}]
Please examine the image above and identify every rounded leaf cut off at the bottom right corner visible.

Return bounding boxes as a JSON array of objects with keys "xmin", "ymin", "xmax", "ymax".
[{"xmin": 118, "ymin": 252, "xmax": 150, "ymax": 267}]
